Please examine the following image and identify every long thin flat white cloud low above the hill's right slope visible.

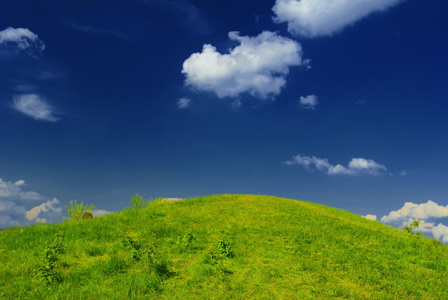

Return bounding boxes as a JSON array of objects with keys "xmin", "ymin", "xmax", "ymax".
[{"xmin": 283, "ymin": 154, "xmax": 387, "ymax": 176}]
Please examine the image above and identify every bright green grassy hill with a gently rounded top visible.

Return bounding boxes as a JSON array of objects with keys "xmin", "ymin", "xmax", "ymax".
[{"xmin": 0, "ymin": 195, "xmax": 448, "ymax": 299}]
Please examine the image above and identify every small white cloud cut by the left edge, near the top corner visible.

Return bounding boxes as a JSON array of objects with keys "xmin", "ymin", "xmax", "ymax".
[{"xmin": 0, "ymin": 27, "xmax": 45, "ymax": 52}]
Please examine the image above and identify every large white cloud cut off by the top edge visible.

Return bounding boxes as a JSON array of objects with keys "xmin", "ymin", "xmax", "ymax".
[{"xmin": 272, "ymin": 0, "xmax": 403, "ymax": 38}]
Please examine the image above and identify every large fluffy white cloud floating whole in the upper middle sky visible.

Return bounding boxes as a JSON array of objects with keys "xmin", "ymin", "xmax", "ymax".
[{"xmin": 182, "ymin": 31, "xmax": 308, "ymax": 99}]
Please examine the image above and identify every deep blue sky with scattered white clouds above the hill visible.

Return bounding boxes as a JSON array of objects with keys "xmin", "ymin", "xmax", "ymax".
[{"xmin": 0, "ymin": 0, "xmax": 448, "ymax": 242}]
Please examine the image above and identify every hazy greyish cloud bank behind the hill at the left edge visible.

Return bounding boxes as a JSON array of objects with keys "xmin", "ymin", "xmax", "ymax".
[{"xmin": 0, "ymin": 178, "xmax": 62, "ymax": 228}]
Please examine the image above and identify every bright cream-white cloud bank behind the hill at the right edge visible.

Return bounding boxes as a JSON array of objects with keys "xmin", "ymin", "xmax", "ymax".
[{"xmin": 380, "ymin": 200, "xmax": 448, "ymax": 243}]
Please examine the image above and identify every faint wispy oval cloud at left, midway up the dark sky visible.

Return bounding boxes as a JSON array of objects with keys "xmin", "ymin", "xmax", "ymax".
[{"xmin": 14, "ymin": 94, "xmax": 58, "ymax": 122}]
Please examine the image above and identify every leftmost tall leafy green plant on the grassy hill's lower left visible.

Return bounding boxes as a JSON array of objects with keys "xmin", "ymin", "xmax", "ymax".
[{"xmin": 39, "ymin": 232, "xmax": 64, "ymax": 285}]
